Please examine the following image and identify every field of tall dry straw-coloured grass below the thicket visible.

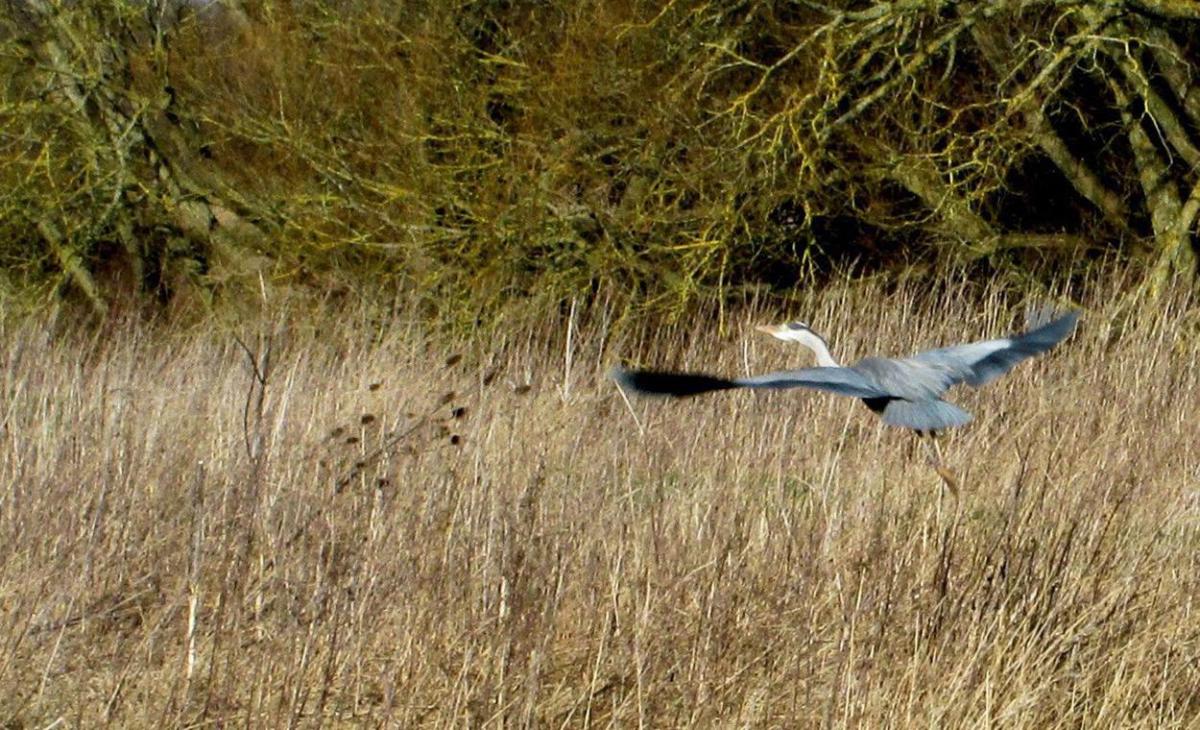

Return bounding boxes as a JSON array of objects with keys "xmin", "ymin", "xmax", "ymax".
[{"xmin": 0, "ymin": 276, "xmax": 1200, "ymax": 728}]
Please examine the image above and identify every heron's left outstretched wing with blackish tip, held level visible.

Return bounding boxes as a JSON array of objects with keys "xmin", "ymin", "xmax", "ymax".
[{"xmin": 612, "ymin": 367, "xmax": 889, "ymax": 397}]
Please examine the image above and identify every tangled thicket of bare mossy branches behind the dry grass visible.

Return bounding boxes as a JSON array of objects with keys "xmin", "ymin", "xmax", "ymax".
[{"xmin": 0, "ymin": 0, "xmax": 1200, "ymax": 315}]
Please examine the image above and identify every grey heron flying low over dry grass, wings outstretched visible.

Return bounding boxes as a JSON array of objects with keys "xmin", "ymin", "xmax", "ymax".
[{"xmin": 613, "ymin": 311, "xmax": 1079, "ymax": 497}]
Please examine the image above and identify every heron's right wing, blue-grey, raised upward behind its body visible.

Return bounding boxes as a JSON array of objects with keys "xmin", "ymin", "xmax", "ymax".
[{"xmin": 907, "ymin": 312, "xmax": 1079, "ymax": 388}]
